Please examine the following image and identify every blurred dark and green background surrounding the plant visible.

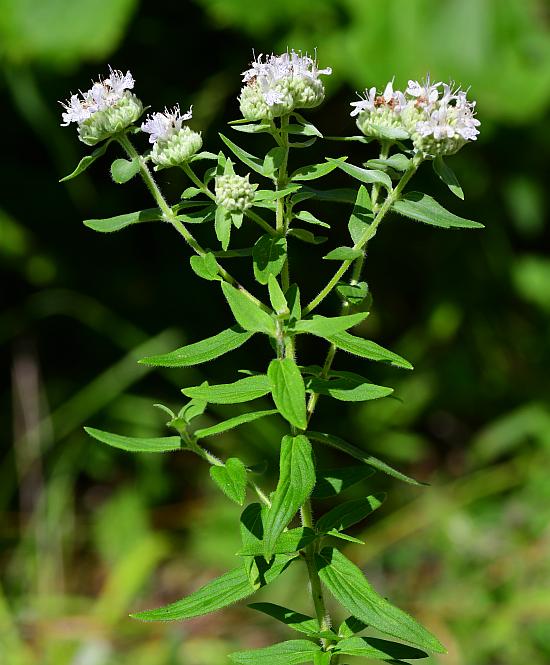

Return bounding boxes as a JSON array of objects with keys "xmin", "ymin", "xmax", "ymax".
[{"xmin": 0, "ymin": 0, "xmax": 550, "ymax": 665}]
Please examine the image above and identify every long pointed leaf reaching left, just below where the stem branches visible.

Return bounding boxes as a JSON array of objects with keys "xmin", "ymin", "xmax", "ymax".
[{"xmin": 138, "ymin": 326, "xmax": 253, "ymax": 367}]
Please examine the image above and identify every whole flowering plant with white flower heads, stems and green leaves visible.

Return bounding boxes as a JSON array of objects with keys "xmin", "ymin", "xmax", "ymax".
[{"xmin": 59, "ymin": 51, "xmax": 481, "ymax": 665}]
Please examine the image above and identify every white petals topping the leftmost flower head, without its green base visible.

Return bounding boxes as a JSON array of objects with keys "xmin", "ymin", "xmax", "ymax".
[{"xmin": 60, "ymin": 66, "xmax": 134, "ymax": 127}]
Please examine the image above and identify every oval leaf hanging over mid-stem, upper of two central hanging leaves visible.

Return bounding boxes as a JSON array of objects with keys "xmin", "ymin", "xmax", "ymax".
[{"xmin": 267, "ymin": 358, "xmax": 307, "ymax": 429}]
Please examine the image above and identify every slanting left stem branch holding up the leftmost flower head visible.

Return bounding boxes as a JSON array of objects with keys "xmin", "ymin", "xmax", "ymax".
[{"xmin": 118, "ymin": 134, "xmax": 271, "ymax": 312}]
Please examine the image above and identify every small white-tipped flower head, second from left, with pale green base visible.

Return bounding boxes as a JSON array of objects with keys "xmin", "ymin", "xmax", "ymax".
[{"xmin": 141, "ymin": 106, "xmax": 202, "ymax": 168}]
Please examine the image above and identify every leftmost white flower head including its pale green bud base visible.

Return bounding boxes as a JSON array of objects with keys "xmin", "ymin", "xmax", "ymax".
[{"xmin": 61, "ymin": 67, "xmax": 143, "ymax": 145}]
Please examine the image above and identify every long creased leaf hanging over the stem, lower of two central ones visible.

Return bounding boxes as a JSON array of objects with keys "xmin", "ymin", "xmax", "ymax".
[{"xmin": 264, "ymin": 434, "xmax": 315, "ymax": 557}]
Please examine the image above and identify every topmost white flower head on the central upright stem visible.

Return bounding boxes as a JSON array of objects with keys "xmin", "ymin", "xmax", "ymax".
[{"xmin": 239, "ymin": 50, "xmax": 332, "ymax": 120}]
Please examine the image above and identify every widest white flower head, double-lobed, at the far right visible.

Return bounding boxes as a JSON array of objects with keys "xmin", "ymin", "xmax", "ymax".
[{"xmin": 351, "ymin": 76, "xmax": 480, "ymax": 156}]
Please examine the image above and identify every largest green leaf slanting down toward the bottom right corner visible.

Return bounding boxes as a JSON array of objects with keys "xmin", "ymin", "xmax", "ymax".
[{"xmin": 315, "ymin": 547, "xmax": 445, "ymax": 653}]
